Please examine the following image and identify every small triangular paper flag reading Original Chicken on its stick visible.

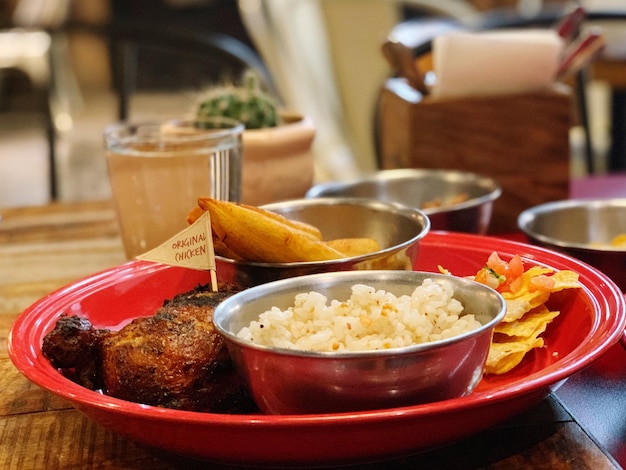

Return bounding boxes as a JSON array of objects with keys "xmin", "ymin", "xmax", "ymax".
[{"xmin": 137, "ymin": 211, "xmax": 217, "ymax": 291}]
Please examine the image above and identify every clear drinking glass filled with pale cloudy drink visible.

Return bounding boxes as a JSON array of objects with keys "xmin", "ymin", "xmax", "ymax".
[{"xmin": 105, "ymin": 116, "xmax": 243, "ymax": 259}]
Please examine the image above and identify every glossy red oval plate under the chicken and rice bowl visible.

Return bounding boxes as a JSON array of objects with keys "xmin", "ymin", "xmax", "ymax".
[{"xmin": 8, "ymin": 232, "xmax": 626, "ymax": 465}]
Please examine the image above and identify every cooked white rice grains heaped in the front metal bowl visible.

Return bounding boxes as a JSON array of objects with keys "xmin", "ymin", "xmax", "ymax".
[{"xmin": 237, "ymin": 279, "xmax": 482, "ymax": 351}]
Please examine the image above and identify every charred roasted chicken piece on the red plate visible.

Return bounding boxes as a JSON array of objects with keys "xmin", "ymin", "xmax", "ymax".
[{"xmin": 42, "ymin": 286, "xmax": 256, "ymax": 413}]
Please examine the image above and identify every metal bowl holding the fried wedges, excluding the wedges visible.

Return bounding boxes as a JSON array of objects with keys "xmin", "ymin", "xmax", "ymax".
[{"xmin": 216, "ymin": 198, "xmax": 430, "ymax": 287}]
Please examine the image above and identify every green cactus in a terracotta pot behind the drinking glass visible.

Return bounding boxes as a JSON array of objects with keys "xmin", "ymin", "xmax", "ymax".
[{"xmin": 196, "ymin": 71, "xmax": 315, "ymax": 205}]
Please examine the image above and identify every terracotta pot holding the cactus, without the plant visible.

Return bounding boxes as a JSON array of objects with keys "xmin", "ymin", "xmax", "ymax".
[{"xmin": 241, "ymin": 116, "xmax": 315, "ymax": 206}]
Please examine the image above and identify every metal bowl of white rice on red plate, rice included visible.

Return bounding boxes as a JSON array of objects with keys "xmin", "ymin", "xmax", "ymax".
[{"xmin": 213, "ymin": 270, "xmax": 506, "ymax": 414}]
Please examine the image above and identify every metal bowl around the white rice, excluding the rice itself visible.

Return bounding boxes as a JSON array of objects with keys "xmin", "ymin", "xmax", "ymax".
[{"xmin": 213, "ymin": 271, "xmax": 506, "ymax": 414}]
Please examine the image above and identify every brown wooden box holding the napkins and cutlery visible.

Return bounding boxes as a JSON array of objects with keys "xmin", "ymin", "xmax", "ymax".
[{"xmin": 377, "ymin": 78, "xmax": 576, "ymax": 234}]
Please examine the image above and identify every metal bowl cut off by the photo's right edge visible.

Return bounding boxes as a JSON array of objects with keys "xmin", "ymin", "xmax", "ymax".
[{"xmin": 518, "ymin": 199, "xmax": 626, "ymax": 291}]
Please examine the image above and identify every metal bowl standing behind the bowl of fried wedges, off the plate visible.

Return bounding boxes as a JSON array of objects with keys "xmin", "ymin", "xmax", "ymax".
[{"xmin": 306, "ymin": 169, "xmax": 502, "ymax": 234}]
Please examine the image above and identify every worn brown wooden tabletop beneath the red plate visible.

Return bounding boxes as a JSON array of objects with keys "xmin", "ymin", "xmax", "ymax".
[{"xmin": 0, "ymin": 201, "xmax": 626, "ymax": 470}]
